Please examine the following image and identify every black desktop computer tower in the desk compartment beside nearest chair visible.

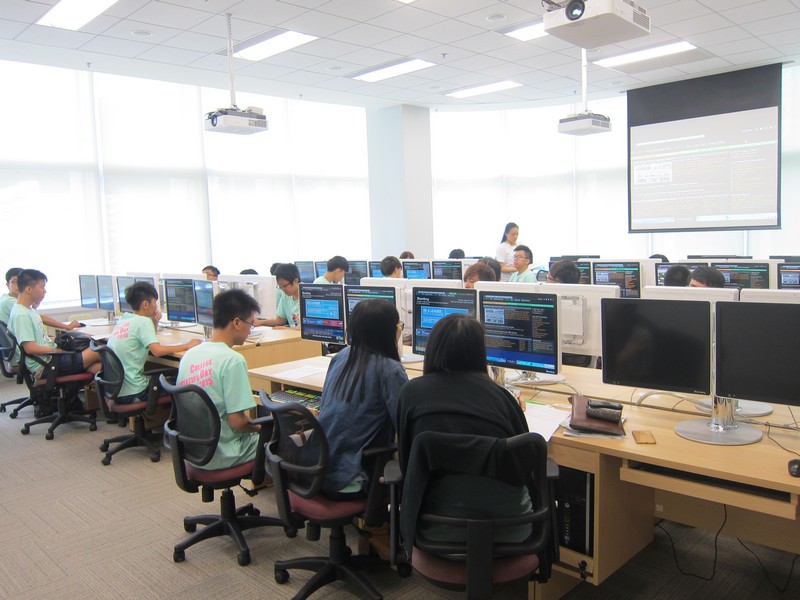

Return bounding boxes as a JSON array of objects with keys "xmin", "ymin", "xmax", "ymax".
[{"xmin": 555, "ymin": 467, "xmax": 594, "ymax": 556}]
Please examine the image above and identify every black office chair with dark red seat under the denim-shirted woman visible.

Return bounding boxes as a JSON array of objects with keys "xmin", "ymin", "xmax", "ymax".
[{"xmin": 261, "ymin": 391, "xmax": 394, "ymax": 600}]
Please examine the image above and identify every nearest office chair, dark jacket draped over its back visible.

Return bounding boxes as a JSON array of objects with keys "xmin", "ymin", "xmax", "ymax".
[{"xmin": 386, "ymin": 431, "xmax": 558, "ymax": 599}]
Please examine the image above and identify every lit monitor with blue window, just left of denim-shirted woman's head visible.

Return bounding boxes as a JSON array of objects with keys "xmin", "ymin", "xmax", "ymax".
[{"xmin": 300, "ymin": 283, "xmax": 345, "ymax": 344}]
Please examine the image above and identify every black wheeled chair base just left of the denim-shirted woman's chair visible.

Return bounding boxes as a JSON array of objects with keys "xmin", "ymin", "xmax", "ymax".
[{"xmin": 172, "ymin": 489, "xmax": 284, "ymax": 566}]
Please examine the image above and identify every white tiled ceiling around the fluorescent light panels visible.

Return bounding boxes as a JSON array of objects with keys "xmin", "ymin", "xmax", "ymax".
[{"xmin": 0, "ymin": 0, "xmax": 800, "ymax": 109}]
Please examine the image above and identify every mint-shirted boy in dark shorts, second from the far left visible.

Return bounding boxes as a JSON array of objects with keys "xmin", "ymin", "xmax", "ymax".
[{"xmin": 8, "ymin": 269, "xmax": 102, "ymax": 378}]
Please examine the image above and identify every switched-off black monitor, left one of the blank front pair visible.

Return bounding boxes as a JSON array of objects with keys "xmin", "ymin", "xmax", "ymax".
[{"xmin": 600, "ymin": 298, "xmax": 720, "ymax": 394}]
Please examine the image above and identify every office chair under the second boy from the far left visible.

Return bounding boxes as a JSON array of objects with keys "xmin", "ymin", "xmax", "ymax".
[{"xmin": 17, "ymin": 343, "xmax": 97, "ymax": 440}]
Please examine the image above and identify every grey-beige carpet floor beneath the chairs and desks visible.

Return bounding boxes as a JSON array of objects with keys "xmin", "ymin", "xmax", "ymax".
[{"xmin": 0, "ymin": 380, "xmax": 800, "ymax": 600}]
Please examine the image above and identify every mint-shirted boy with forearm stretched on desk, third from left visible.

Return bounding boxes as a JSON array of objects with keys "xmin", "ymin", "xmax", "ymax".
[{"xmin": 108, "ymin": 281, "xmax": 201, "ymax": 404}]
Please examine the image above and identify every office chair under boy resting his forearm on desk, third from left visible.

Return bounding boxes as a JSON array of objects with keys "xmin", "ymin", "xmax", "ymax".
[{"xmin": 89, "ymin": 341, "xmax": 174, "ymax": 465}]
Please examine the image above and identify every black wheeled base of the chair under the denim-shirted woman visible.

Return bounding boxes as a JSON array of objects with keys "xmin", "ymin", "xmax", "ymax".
[{"xmin": 275, "ymin": 526, "xmax": 389, "ymax": 600}]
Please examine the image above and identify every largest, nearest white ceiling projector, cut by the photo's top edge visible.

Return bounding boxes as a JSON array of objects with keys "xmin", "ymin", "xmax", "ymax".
[{"xmin": 544, "ymin": 0, "xmax": 650, "ymax": 48}]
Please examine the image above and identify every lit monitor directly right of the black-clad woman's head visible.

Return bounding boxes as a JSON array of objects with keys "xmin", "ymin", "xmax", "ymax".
[{"xmin": 478, "ymin": 290, "xmax": 561, "ymax": 375}]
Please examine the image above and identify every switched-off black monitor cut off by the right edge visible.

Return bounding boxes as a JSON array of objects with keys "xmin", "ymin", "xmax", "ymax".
[{"xmin": 716, "ymin": 302, "xmax": 800, "ymax": 406}]
